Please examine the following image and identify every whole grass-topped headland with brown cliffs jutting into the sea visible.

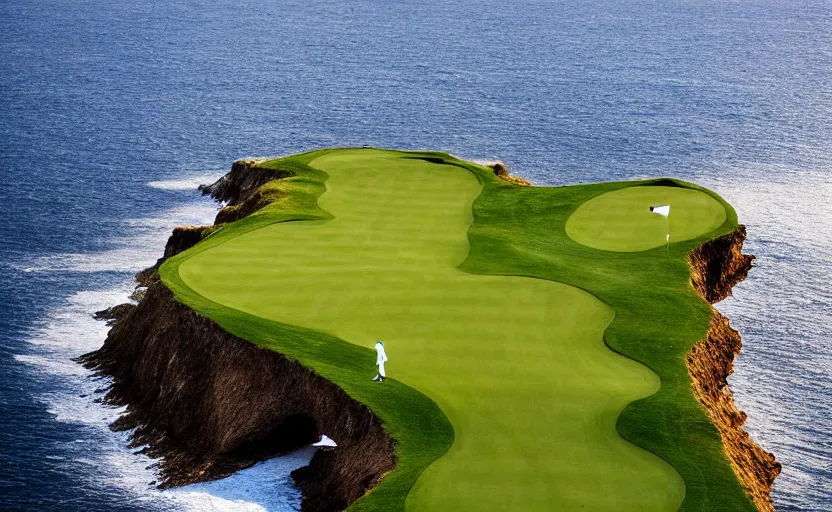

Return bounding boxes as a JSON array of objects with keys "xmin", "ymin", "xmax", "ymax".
[{"xmin": 82, "ymin": 148, "xmax": 780, "ymax": 512}]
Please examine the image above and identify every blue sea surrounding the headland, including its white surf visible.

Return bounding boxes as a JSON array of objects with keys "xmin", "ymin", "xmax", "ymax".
[{"xmin": 0, "ymin": 0, "xmax": 832, "ymax": 511}]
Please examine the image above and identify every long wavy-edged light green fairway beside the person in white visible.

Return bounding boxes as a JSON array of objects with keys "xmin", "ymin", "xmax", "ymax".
[{"xmin": 177, "ymin": 150, "xmax": 684, "ymax": 511}]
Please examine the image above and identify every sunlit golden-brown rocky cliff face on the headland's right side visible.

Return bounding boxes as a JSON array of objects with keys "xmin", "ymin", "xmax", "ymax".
[{"xmin": 687, "ymin": 225, "xmax": 781, "ymax": 512}]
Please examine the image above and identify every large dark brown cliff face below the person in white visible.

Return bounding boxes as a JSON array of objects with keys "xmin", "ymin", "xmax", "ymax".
[{"xmin": 80, "ymin": 282, "xmax": 395, "ymax": 512}]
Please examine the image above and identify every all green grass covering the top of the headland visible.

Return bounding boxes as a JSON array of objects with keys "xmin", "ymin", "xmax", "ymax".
[{"xmin": 156, "ymin": 149, "xmax": 753, "ymax": 511}]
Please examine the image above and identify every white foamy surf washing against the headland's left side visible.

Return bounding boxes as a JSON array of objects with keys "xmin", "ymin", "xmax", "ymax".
[{"xmin": 15, "ymin": 202, "xmax": 313, "ymax": 512}]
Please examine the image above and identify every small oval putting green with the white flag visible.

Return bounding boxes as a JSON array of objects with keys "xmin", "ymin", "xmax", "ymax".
[{"xmin": 566, "ymin": 186, "xmax": 726, "ymax": 252}]
